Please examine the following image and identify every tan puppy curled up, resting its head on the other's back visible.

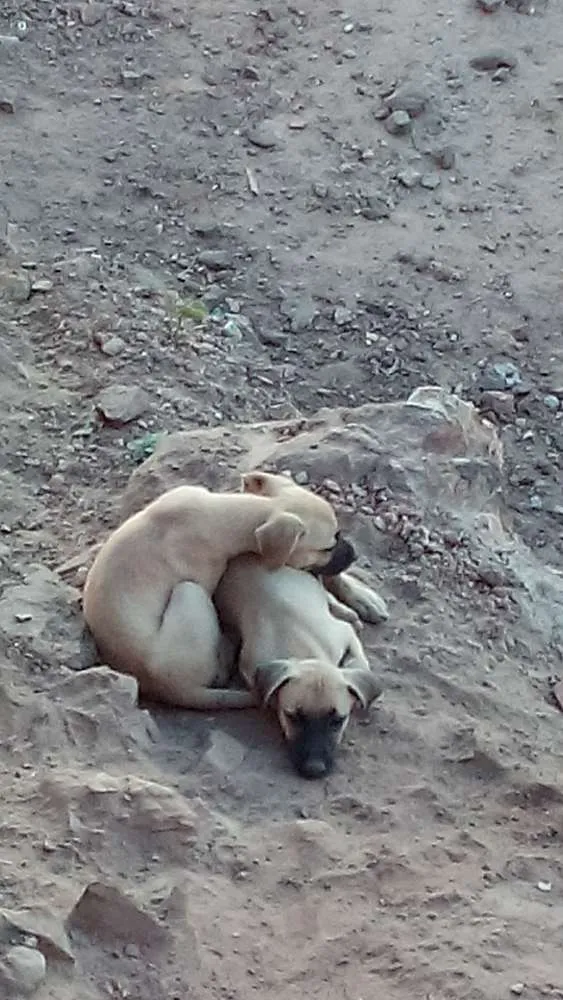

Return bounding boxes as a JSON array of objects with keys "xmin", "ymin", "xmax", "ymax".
[{"xmin": 83, "ymin": 472, "xmax": 354, "ymax": 710}]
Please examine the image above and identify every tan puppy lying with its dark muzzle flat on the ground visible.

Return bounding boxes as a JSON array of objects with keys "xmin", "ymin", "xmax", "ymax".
[{"xmin": 215, "ymin": 555, "xmax": 381, "ymax": 778}]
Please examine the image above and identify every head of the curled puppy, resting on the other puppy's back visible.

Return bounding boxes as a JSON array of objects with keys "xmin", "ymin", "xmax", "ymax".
[{"xmin": 242, "ymin": 472, "xmax": 356, "ymax": 576}]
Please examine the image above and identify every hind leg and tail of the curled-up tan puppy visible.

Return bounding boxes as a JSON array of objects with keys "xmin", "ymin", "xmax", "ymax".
[{"xmin": 145, "ymin": 583, "xmax": 258, "ymax": 711}]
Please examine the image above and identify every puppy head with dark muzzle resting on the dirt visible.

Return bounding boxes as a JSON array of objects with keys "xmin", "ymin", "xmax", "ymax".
[{"xmin": 254, "ymin": 660, "xmax": 381, "ymax": 778}]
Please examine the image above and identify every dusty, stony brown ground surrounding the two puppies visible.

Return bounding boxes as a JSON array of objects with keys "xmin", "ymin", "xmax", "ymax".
[{"xmin": 0, "ymin": 0, "xmax": 563, "ymax": 1000}]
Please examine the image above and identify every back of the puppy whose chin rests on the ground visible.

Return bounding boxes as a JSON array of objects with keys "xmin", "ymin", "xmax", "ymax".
[{"xmin": 214, "ymin": 555, "xmax": 351, "ymax": 681}]
